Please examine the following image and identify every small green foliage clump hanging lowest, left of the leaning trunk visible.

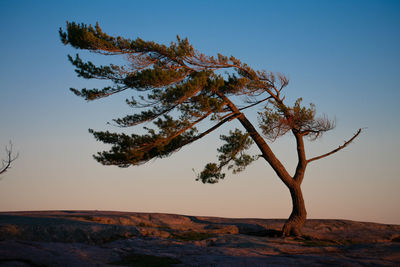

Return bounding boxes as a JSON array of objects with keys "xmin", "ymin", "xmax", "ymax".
[{"xmin": 196, "ymin": 129, "xmax": 258, "ymax": 184}]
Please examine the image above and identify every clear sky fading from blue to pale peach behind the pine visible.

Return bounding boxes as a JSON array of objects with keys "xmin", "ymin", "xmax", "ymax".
[{"xmin": 0, "ymin": 0, "xmax": 400, "ymax": 224}]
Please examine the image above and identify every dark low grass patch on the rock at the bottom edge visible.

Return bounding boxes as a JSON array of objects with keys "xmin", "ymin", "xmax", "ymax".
[{"xmin": 109, "ymin": 254, "xmax": 181, "ymax": 267}]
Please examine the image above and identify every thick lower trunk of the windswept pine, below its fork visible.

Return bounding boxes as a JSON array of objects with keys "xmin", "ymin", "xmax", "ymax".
[{"xmin": 282, "ymin": 183, "xmax": 307, "ymax": 236}]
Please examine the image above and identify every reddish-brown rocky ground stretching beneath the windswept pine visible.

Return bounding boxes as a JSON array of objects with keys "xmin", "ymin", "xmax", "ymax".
[{"xmin": 0, "ymin": 211, "xmax": 400, "ymax": 267}]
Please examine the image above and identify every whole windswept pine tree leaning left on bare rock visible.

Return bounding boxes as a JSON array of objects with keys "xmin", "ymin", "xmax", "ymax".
[{"xmin": 59, "ymin": 22, "xmax": 361, "ymax": 236}]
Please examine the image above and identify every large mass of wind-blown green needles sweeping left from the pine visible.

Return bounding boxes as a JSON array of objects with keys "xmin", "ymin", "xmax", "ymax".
[{"xmin": 59, "ymin": 22, "xmax": 262, "ymax": 170}]
